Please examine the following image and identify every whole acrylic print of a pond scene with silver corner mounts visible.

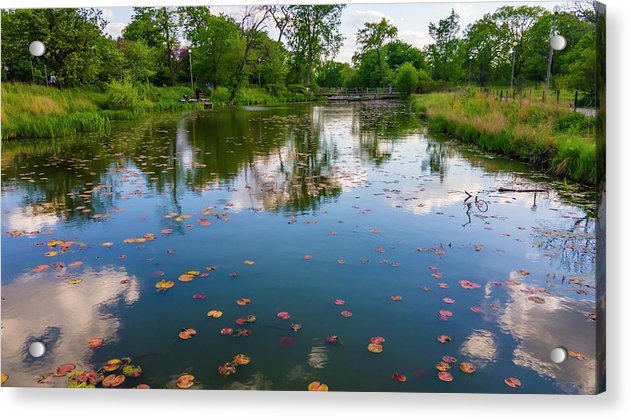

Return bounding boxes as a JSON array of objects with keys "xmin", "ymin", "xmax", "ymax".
[{"xmin": 1, "ymin": 2, "xmax": 605, "ymax": 394}]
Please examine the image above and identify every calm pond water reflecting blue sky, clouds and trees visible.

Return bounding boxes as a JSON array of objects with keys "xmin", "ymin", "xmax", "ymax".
[{"xmin": 2, "ymin": 102, "xmax": 596, "ymax": 393}]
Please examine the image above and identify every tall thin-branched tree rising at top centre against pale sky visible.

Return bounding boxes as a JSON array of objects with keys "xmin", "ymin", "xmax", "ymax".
[{"xmin": 287, "ymin": 5, "xmax": 344, "ymax": 85}]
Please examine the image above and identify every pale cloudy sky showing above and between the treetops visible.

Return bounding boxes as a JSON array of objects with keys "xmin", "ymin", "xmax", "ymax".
[{"xmin": 102, "ymin": 2, "xmax": 563, "ymax": 62}]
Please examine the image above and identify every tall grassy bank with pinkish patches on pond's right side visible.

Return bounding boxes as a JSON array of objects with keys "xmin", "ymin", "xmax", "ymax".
[{"xmin": 411, "ymin": 89, "xmax": 596, "ymax": 184}]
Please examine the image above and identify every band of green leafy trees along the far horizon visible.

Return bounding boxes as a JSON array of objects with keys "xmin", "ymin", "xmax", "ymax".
[{"xmin": 2, "ymin": 2, "xmax": 596, "ymax": 101}]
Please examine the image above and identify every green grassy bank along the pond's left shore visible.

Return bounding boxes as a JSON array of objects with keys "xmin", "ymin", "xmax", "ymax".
[{"xmin": 1, "ymin": 82, "xmax": 314, "ymax": 140}]
